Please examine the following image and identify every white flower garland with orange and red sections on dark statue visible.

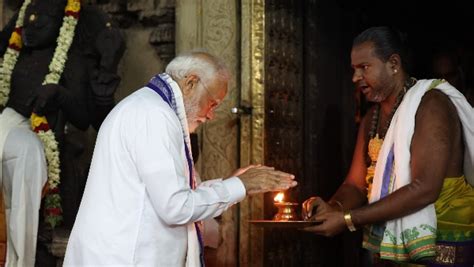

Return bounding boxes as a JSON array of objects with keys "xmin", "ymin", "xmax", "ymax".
[{"xmin": 0, "ymin": 0, "xmax": 81, "ymax": 228}]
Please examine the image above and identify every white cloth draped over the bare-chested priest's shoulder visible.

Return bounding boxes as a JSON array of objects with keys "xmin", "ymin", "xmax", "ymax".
[{"xmin": 370, "ymin": 80, "xmax": 474, "ymax": 262}]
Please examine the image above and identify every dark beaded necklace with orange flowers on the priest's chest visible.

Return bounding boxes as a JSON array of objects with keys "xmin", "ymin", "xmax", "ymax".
[{"xmin": 365, "ymin": 77, "xmax": 417, "ymax": 198}]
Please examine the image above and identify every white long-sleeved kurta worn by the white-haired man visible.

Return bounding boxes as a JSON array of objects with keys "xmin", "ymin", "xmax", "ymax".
[{"xmin": 64, "ymin": 83, "xmax": 245, "ymax": 266}]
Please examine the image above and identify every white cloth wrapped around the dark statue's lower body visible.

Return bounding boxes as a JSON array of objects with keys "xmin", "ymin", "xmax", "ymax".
[{"xmin": 0, "ymin": 108, "xmax": 47, "ymax": 266}]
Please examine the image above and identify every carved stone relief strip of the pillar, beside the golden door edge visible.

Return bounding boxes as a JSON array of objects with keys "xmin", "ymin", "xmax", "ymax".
[{"xmin": 200, "ymin": 0, "xmax": 239, "ymax": 266}]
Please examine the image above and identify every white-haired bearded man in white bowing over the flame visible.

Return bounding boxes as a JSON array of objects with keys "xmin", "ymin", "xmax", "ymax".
[{"xmin": 64, "ymin": 52, "xmax": 296, "ymax": 266}]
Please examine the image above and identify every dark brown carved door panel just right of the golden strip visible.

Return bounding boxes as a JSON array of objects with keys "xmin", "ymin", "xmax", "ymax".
[{"xmin": 263, "ymin": 0, "xmax": 308, "ymax": 266}]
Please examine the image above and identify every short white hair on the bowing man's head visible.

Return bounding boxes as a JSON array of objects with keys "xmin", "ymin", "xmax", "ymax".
[{"xmin": 165, "ymin": 50, "xmax": 230, "ymax": 86}]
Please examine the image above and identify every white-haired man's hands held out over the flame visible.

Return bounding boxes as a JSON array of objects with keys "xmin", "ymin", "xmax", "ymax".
[{"xmin": 236, "ymin": 165, "xmax": 297, "ymax": 195}]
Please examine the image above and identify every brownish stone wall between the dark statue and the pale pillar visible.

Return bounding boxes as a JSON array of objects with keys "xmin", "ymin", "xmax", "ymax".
[{"xmin": 87, "ymin": 0, "xmax": 175, "ymax": 100}]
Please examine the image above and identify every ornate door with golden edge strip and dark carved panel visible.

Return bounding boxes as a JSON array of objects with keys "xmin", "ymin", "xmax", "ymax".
[{"xmin": 240, "ymin": 0, "xmax": 304, "ymax": 266}]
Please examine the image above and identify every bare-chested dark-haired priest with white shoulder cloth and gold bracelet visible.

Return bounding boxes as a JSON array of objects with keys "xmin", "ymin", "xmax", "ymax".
[{"xmin": 303, "ymin": 27, "xmax": 474, "ymax": 266}]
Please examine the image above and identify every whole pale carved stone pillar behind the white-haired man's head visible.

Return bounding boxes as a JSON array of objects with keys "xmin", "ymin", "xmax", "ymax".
[{"xmin": 176, "ymin": 0, "xmax": 240, "ymax": 266}]
